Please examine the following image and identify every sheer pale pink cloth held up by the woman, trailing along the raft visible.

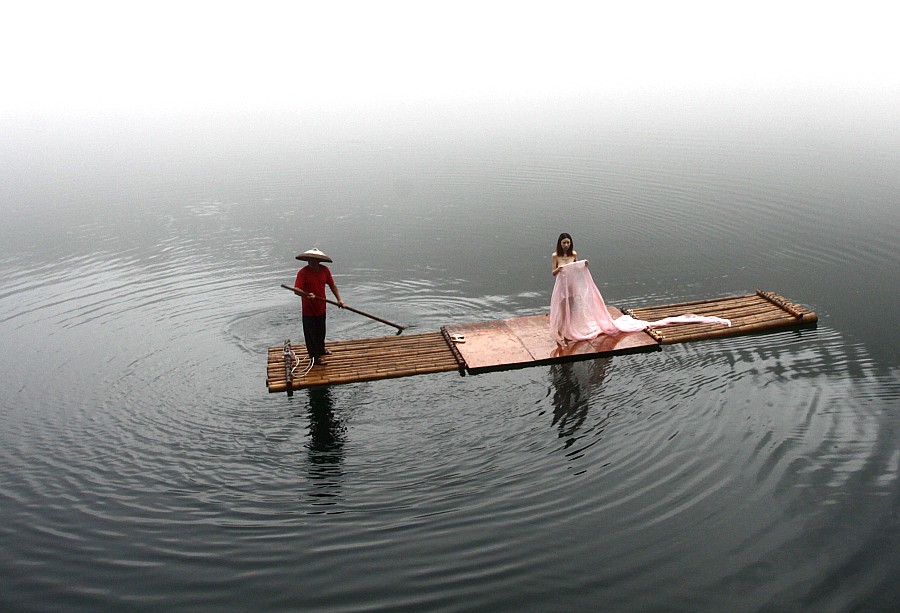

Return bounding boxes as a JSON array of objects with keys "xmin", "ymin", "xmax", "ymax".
[{"xmin": 550, "ymin": 260, "xmax": 731, "ymax": 345}]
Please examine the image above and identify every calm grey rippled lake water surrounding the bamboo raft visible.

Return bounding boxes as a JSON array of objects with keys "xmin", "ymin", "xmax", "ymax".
[{"xmin": 0, "ymin": 95, "xmax": 900, "ymax": 611}]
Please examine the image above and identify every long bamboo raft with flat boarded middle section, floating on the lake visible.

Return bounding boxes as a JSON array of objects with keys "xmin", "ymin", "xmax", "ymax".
[{"xmin": 266, "ymin": 291, "xmax": 818, "ymax": 395}]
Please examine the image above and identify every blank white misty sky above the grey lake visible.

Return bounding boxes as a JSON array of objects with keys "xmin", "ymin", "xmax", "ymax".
[{"xmin": 0, "ymin": 0, "xmax": 900, "ymax": 112}]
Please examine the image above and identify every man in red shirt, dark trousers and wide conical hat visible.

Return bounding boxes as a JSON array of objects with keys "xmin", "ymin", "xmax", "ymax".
[{"xmin": 294, "ymin": 248, "xmax": 344, "ymax": 366}]
